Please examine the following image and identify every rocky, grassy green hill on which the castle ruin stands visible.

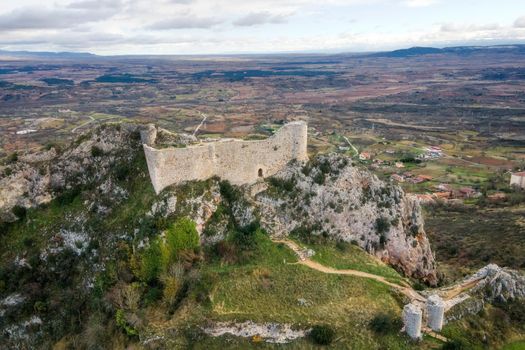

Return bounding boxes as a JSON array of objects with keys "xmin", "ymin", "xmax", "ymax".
[{"xmin": 0, "ymin": 123, "xmax": 524, "ymax": 349}]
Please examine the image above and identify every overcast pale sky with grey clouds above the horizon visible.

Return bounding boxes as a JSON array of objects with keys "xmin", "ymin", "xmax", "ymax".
[{"xmin": 0, "ymin": 0, "xmax": 525, "ymax": 54}]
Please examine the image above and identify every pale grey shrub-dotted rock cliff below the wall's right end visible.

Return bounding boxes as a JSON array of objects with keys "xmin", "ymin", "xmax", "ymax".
[{"xmin": 256, "ymin": 155, "xmax": 437, "ymax": 285}]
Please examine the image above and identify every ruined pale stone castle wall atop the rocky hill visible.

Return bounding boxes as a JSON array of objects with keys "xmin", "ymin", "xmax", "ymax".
[{"xmin": 143, "ymin": 122, "xmax": 308, "ymax": 193}]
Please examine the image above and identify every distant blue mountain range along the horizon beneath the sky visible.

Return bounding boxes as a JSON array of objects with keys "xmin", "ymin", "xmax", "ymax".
[{"xmin": 0, "ymin": 45, "xmax": 525, "ymax": 59}]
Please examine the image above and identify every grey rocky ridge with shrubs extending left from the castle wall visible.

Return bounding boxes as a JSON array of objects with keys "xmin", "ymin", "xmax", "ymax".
[{"xmin": 0, "ymin": 124, "xmax": 140, "ymax": 222}]
